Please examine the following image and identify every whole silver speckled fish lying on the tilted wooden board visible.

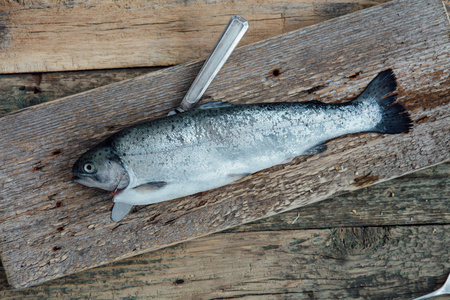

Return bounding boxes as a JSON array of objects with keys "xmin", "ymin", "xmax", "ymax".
[{"xmin": 72, "ymin": 69, "xmax": 412, "ymax": 222}]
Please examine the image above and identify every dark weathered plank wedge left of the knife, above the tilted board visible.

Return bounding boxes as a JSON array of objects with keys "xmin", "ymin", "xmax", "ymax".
[{"xmin": 0, "ymin": 67, "xmax": 161, "ymax": 116}]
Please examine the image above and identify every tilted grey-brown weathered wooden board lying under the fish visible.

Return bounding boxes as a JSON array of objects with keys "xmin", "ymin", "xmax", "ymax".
[{"xmin": 0, "ymin": 0, "xmax": 450, "ymax": 287}]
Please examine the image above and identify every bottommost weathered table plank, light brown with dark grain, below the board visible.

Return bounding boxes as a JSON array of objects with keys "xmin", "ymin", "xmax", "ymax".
[{"xmin": 0, "ymin": 225, "xmax": 450, "ymax": 300}]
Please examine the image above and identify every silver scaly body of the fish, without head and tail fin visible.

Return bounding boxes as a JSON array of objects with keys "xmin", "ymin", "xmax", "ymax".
[{"xmin": 111, "ymin": 103, "xmax": 376, "ymax": 205}]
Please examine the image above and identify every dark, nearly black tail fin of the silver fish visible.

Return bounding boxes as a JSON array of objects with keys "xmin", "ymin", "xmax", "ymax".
[{"xmin": 354, "ymin": 69, "xmax": 412, "ymax": 134}]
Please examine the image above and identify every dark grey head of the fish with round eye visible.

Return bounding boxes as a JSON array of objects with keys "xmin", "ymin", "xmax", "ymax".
[{"xmin": 72, "ymin": 146, "xmax": 130, "ymax": 191}]
